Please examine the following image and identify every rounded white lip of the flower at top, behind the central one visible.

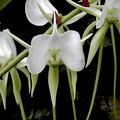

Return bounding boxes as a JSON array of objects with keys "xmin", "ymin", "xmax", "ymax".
[{"xmin": 25, "ymin": 0, "xmax": 57, "ymax": 26}]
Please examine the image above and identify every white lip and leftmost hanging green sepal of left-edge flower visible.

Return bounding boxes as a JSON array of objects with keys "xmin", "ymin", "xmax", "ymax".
[{"xmin": 0, "ymin": 31, "xmax": 16, "ymax": 109}]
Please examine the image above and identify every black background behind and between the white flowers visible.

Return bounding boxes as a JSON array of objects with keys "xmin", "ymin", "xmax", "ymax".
[{"xmin": 0, "ymin": 0, "xmax": 120, "ymax": 120}]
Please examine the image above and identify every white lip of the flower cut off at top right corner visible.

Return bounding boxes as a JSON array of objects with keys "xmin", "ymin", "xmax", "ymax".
[{"xmin": 96, "ymin": 0, "xmax": 120, "ymax": 28}]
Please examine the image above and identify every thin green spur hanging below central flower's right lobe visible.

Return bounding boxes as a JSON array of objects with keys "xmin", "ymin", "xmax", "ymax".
[{"xmin": 67, "ymin": 68, "xmax": 77, "ymax": 120}]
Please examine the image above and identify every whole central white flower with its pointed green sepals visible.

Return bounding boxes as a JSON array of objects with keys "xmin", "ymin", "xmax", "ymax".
[{"xmin": 27, "ymin": 14, "xmax": 91, "ymax": 107}]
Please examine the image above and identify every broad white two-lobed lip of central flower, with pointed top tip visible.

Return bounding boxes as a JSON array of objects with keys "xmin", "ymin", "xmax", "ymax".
[{"xmin": 27, "ymin": 12, "xmax": 85, "ymax": 74}]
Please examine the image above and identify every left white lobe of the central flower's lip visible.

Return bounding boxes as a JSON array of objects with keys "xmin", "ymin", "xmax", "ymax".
[{"xmin": 27, "ymin": 35, "xmax": 51, "ymax": 74}]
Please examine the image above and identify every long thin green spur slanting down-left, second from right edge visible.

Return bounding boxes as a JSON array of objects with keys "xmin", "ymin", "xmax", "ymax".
[{"xmin": 86, "ymin": 41, "xmax": 104, "ymax": 120}]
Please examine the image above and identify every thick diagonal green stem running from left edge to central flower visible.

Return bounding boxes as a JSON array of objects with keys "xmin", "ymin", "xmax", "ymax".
[{"xmin": 0, "ymin": 49, "xmax": 28, "ymax": 77}]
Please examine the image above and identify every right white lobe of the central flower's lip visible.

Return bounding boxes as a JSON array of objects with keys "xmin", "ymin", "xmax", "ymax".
[{"xmin": 55, "ymin": 30, "xmax": 85, "ymax": 71}]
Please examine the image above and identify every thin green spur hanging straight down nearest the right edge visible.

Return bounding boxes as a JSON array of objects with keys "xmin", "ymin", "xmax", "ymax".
[{"xmin": 110, "ymin": 25, "xmax": 118, "ymax": 120}]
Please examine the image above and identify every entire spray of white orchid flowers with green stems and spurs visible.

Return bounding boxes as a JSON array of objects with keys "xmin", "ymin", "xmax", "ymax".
[{"xmin": 0, "ymin": 0, "xmax": 120, "ymax": 120}]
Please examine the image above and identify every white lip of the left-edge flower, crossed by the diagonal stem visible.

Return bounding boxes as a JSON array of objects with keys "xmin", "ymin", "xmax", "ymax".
[{"xmin": 0, "ymin": 29, "xmax": 27, "ymax": 68}]
